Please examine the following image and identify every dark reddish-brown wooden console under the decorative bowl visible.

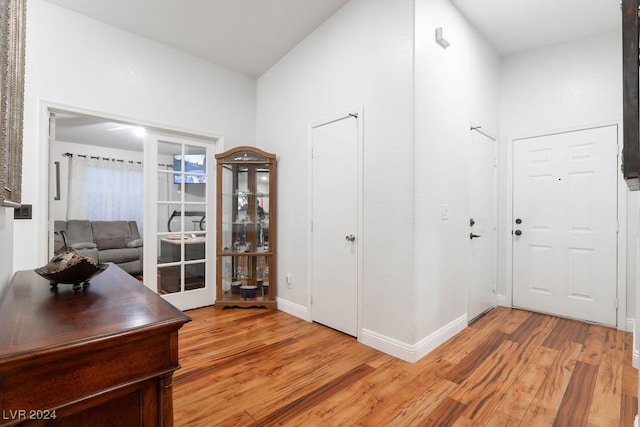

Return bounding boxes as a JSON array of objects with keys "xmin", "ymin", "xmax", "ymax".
[{"xmin": 0, "ymin": 264, "xmax": 191, "ymax": 426}]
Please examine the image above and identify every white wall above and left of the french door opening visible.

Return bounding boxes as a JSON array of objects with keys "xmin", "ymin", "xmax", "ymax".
[{"xmin": 13, "ymin": 0, "xmax": 256, "ymax": 270}]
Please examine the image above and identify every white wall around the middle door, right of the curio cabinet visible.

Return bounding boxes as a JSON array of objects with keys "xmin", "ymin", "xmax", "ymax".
[{"xmin": 257, "ymin": 0, "xmax": 415, "ymax": 342}]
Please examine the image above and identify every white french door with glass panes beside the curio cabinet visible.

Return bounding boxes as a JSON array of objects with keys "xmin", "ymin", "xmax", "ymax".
[{"xmin": 144, "ymin": 133, "xmax": 216, "ymax": 310}]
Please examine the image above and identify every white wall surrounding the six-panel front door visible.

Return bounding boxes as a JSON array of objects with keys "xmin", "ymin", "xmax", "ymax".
[{"xmin": 498, "ymin": 31, "xmax": 638, "ymax": 320}]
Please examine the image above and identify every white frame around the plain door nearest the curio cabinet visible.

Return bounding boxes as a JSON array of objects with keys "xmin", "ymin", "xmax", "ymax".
[{"xmin": 305, "ymin": 106, "xmax": 364, "ymax": 341}]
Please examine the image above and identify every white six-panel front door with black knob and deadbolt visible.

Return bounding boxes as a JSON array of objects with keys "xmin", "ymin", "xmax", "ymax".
[{"xmin": 512, "ymin": 126, "xmax": 618, "ymax": 325}]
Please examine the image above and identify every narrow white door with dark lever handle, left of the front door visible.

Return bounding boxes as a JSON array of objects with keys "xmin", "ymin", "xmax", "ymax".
[{"xmin": 467, "ymin": 131, "xmax": 497, "ymax": 320}]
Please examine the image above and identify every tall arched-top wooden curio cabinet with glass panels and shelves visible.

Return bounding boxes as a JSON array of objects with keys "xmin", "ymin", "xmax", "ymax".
[{"xmin": 215, "ymin": 147, "xmax": 276, "ymax": 308}]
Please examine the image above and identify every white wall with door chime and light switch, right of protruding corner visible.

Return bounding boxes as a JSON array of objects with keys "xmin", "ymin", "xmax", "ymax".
[{"xmin": 415, "ymin": 0, "xmax": 500, "ymax": 339}]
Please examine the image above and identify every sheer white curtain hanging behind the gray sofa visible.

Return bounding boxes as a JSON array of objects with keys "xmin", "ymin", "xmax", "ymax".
[{"xmin": 67, "ymin": 156, "xmax": 144, "ymax": 234}]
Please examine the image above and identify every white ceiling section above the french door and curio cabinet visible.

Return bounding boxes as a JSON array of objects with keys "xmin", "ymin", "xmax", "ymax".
[{"xmin": 42, "ymin": 0, "xmax": 348, "ymax": 77}]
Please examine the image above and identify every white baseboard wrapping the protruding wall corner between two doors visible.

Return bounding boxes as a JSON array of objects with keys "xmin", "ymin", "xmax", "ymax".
[{"xmin": 358, "ymin": 314, "xmax": 467, "ymax": 363}]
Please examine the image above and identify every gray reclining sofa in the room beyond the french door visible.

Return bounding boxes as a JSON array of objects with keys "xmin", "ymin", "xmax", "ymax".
[{"xmin": 54, "ymin": 219, "xmax": 142, "ymax": 275}]
